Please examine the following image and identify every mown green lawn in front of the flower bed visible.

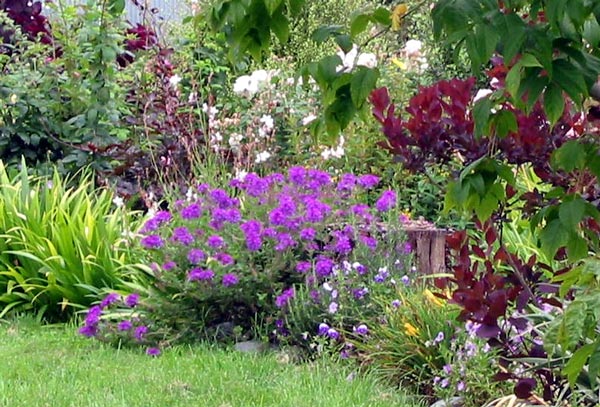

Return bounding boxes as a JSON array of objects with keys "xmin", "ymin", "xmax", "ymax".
[{"xmin": 0, "ymin": 321, "xmax": 418, "ymax": 407}]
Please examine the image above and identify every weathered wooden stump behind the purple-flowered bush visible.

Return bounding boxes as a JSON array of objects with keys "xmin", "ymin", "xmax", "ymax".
[{"xmin": 402, "ymin": 219, "xmax": 448, "ymax": 274}]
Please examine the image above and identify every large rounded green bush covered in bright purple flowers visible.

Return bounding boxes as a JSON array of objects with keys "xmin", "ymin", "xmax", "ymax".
[{"xmin": 79, "ymin": 167, "xmax": 410, "ymax": 352}]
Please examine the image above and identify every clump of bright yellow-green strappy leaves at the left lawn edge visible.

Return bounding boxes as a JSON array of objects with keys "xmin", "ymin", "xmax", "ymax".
[{"xmin": 0, "ymin": 161, "xmax": 148, "ymax": 321}]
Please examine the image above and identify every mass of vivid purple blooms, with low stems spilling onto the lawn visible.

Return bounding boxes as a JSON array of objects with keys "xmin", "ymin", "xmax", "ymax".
[{"xmin": 81, "ymin": 167, "xmax": 410, "ymax": 356}]
